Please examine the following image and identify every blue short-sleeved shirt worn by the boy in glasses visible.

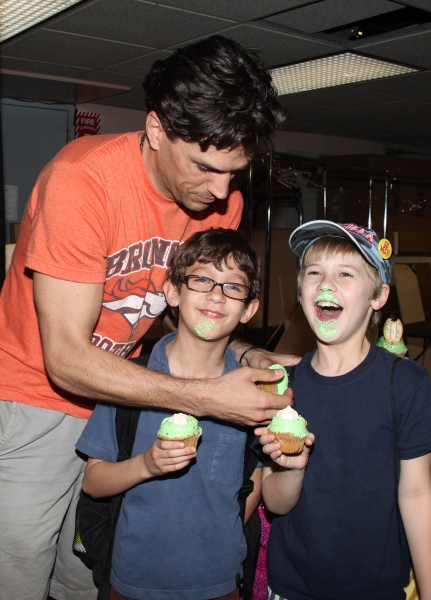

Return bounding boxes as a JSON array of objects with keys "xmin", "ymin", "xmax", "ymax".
[{"xmin": 76, "ymin": 334, "xmax": 247, "ymax": 600}]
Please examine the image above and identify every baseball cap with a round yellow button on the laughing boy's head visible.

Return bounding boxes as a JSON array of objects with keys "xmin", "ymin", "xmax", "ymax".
[{"xmin": 289, "ymin": 221, "xmax": 392, "ymax": 284}]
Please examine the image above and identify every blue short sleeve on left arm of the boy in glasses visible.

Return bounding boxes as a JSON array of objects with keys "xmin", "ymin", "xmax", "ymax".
[{"xmin": 76, "ymin": 404, "xmax": 118, "ymax": 462}]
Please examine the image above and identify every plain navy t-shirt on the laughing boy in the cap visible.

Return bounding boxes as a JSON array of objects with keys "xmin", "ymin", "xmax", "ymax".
[{"xmin": 268, "ymin": 344, "xmax": 431, "ymax": 600}]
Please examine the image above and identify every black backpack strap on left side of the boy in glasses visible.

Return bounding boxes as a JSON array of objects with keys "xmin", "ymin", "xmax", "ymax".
[{"xmin": 97, "ymin": 354, "xmax": 150, "ymax": 600}]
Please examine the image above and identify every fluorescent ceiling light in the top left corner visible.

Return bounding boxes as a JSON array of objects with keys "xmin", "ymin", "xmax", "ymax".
[{"xmin": 0, "ymin": 0, "xmax": 81, "ymax": 42}]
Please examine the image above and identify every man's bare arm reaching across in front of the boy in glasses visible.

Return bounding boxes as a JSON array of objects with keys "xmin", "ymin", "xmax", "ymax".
[{"xmin": 33, "ymin": 272, "xmax": 287, "ymax": 425}]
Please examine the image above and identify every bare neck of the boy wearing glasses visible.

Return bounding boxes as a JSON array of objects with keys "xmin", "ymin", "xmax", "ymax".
[{"xmin": 166, "ymin": 329, "xmax": 228, "ymax": 379}]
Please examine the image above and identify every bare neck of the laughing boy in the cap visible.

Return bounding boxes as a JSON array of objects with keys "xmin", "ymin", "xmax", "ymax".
[{"xmin": 311, "ymin": 333, "xmax": 370, "ymax": 377}]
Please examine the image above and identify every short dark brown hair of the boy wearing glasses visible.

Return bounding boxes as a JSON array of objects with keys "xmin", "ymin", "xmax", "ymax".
[{"xmin": 166, "ymin": 228, "xmax": 261, "ymax": 304}]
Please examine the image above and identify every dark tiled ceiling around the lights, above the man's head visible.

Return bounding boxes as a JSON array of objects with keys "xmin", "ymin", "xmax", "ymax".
[{"xmin": 1, "ymin": 0, "xmax": 431, "ymax": 151}]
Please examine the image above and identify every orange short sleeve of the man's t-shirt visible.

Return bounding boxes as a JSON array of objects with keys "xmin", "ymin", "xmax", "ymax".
[{"xmin": 26, "ymin": 160, "xmax": 111, "ymax": 283}]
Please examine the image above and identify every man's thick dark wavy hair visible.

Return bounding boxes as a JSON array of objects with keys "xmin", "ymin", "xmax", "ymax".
[{"xmin": 143, "ymin": 35, "xmax": 287, "ymax": 154}]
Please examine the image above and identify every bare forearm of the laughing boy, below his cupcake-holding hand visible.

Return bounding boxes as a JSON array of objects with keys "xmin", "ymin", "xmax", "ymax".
[{"xmin": 262, "ymin": 466, "xmax": 305, "ymax": 515}]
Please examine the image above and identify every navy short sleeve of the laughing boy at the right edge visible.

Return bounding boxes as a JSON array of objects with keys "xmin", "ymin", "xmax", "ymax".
[{"xmin": 394, "ymin": 359, "xmax": 431, "ymax": 460}]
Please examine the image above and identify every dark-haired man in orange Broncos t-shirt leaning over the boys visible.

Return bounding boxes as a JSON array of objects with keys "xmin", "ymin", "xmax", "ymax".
[{"xmin": 0, "ymin": 36, "xmax": 294, "ymax": 600}]
